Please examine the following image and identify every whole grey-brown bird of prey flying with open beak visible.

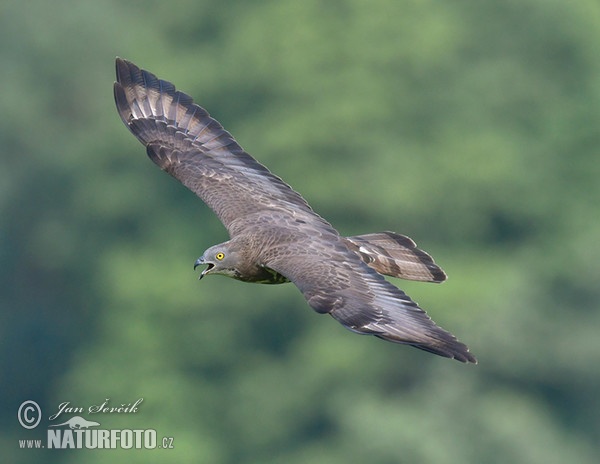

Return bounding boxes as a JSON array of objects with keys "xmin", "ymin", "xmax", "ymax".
[{"xmin": 114, "ymin": 58, "xmax": 477, "ymax": 363}]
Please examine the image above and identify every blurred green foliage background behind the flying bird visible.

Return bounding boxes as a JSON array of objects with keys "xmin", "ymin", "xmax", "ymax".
[{"xmin": 0, "ymin": 0, "xmax": 600, "ymax": 464}]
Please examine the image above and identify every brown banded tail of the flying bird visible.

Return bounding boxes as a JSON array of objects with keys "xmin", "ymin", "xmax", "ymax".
[{"xmin": 345, "ymin": 232, "xmax": 447, "ymax": 282}]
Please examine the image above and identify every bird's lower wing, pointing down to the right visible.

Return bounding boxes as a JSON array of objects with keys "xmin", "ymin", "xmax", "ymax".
[{"xmin": 265, "ymin": 234, "xmax": 477, "ymax": 363}]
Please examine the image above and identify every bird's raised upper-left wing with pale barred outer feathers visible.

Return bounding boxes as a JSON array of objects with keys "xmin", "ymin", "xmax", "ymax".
[{"xmin": 114, "ymin": 58, "xmax": 330, "ymax": 235}]
